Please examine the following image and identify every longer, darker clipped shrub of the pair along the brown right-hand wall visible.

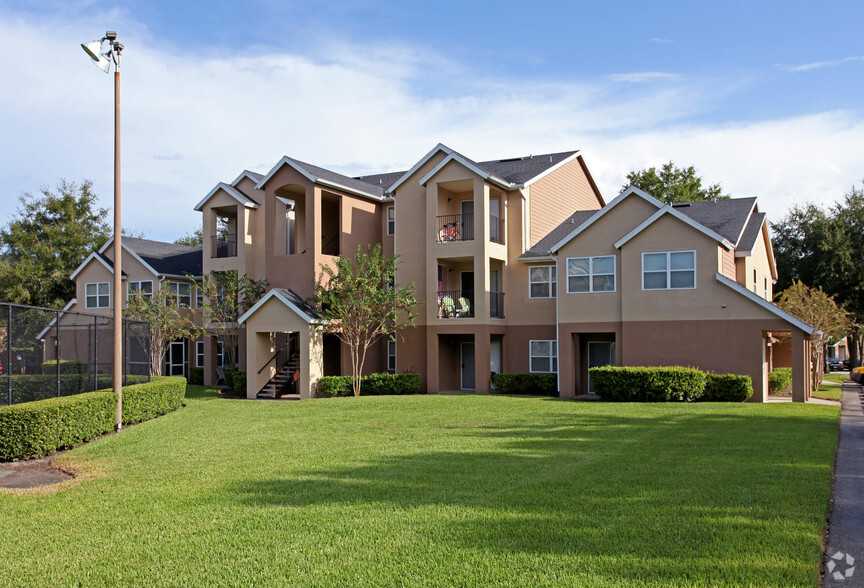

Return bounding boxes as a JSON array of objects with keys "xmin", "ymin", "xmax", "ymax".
[{"xmin": 589, "ymin": 366, "xmax": 707, "ymax": 402}]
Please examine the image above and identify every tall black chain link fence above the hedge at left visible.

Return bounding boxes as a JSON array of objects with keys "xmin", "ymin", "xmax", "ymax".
[{"xmin": 0, "ymin": 303, "xmax": 151, "ymax": 406}]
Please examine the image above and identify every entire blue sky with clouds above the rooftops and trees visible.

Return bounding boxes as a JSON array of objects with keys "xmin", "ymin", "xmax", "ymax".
[{"xmin": 0, "ymin": 0, "xmax": 864, "ymax": 240}]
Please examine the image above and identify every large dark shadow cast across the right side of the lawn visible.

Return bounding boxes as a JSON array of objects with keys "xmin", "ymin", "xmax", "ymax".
[{"xmin": 228, "ymin": 412, "xmax": 836, "ymax": 585}]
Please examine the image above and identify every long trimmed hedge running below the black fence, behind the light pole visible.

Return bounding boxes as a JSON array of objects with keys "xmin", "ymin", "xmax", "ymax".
[{"xmin": 0, "ymin": 376, "xmax": 186, "ymax": 461}]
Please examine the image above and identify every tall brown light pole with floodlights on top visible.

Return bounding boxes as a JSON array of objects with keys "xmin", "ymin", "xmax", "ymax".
[{"xmin": 81, "ymin": 31, "xmax": 123, "ymax": 431}]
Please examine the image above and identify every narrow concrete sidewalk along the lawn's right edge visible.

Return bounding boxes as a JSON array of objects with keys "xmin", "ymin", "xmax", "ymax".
[{"xmin": 824, "ymin": 382, "xmax": 864, "ymax": 587}]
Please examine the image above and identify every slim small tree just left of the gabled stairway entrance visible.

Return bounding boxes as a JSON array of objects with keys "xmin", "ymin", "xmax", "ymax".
[{"xmin": 198, "ymin": 270, "xmax": 269, "ymax": 369}]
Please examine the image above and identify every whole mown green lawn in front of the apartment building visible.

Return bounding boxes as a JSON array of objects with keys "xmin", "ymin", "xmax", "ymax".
[{"xmin": 0, "ymin": 387, "xmax": 839, "ymax": 586}]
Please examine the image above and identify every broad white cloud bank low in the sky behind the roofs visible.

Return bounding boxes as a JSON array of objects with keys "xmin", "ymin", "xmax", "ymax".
[{"xmin": 0, "ymin": 8, "xmax": 864, "ymax": 240}]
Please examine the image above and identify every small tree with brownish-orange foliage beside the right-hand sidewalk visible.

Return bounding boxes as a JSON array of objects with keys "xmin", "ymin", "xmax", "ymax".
[{"xmin": 777, "ymin": 281, "xmax": 850, "ymax": 390}]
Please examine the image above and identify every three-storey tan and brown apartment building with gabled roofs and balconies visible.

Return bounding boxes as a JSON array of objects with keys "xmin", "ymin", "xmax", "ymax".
[{"xmin": 196, "ymin": 144, "xmax": 812, "ymax": 401}]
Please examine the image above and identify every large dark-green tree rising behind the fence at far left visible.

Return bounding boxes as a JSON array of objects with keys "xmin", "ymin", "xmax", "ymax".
[{"xmin": 0, "ymin": 180, "xmax": 110, "ymax": 307}]
